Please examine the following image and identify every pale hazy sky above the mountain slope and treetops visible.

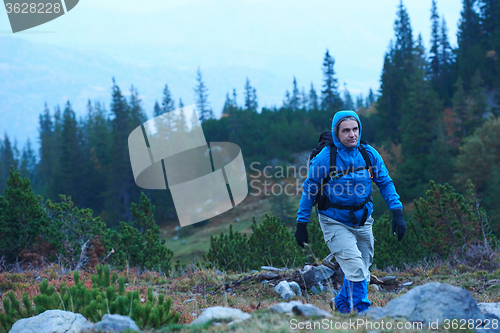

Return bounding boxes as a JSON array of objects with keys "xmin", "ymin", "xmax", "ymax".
[{"xmin": 0, "ymin": 0, "xmax": 462, "ymax": 127}]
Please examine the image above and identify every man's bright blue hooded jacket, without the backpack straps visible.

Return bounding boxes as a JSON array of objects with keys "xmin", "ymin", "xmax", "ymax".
[{"xmin": 297, "ymin": 111, "xmax": 403, "ymax": 226}]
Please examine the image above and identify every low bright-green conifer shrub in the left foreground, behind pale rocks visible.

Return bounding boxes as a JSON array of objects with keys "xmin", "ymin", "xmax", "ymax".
[{"xmin": 0, "ymin": 265, "xmax": 180, "ymax": 332}]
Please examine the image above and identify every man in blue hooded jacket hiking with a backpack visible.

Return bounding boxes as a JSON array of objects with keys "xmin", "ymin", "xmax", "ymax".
[{"xmin": 295, "ymin": 111, "xmax": 406, "ymax": 313}]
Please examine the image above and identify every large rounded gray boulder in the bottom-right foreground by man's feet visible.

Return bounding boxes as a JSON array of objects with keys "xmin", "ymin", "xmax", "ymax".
[{"xmin": 364, "ymin": 282, "xmax": 500, "ymax": 332}]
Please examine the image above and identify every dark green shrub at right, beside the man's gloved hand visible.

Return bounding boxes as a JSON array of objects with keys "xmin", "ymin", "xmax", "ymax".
[{"xmin": 373, "ymin": 181, "xmax": 496, "ymax": 268}]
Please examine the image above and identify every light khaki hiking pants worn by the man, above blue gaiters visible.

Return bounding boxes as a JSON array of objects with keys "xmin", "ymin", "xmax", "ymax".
[{"xmin": 319, "ymin": 214, "xmax": 374, "ymax": 282}]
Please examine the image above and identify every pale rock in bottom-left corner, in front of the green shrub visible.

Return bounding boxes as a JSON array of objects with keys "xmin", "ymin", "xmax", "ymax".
[{"xmin": 10, "ymin": 310, "xmax": 88, "ymax": 333}]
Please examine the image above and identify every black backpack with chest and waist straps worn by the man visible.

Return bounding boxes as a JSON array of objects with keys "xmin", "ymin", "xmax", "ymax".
[{"xmin": 309, "ymin": 131, "xmax": 373, "ymax": 226}]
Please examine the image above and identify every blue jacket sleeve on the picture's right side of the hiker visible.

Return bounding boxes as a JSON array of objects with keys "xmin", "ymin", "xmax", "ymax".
[{"xmin": 369, "ymin": 147, "xmax": 403, "ymax": 211}]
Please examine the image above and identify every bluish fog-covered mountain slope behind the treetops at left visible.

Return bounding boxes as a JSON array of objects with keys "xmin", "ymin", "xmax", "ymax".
[{"xmin": 0, "ymin": 36, "xmax": 300, "ymax": 149}]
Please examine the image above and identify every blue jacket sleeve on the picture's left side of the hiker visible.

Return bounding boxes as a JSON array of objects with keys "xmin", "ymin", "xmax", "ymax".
[{"xmin": 297, "ymin": 148, "xmax": 330, "ymax": 223}]
